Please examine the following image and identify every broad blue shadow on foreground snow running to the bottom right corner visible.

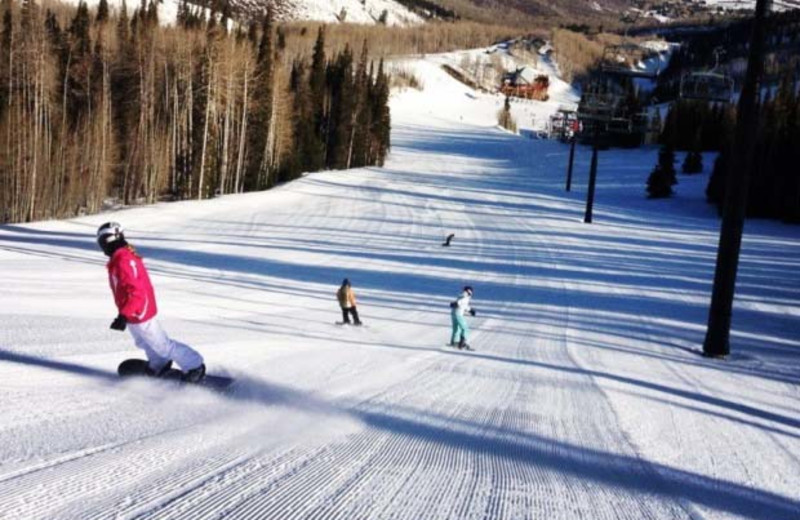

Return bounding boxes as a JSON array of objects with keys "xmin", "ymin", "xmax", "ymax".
[{"xmin": 223, "ymin": 380, "xmax": 800, "ymax": 519}]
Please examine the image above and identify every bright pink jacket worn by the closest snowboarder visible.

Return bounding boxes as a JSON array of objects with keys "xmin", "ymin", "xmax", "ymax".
[{"xmin": 106, "ymin": 246, "xmax": 158, "ymax": 323}]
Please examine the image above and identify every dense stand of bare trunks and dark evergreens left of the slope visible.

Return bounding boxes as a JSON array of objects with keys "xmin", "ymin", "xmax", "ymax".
[{"xmin": 0, "ymin": 0, "xmax": 390, "ymax": 222}]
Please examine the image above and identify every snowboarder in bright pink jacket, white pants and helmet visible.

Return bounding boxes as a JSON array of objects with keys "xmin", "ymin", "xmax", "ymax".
[{"xmin": 97, "ymin": 222, "xmax": 206, "ymax": 382}]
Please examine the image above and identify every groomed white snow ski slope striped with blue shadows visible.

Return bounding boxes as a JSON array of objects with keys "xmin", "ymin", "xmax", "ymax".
[{"xmin": 0, "ymin": 60, "xmax": 800, "ymax": 520}]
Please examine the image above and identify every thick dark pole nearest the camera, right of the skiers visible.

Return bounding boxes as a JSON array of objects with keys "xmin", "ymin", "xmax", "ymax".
[{"xmin": 703, "ymin": 0, "xmax": 771, "ymax": 357}]
